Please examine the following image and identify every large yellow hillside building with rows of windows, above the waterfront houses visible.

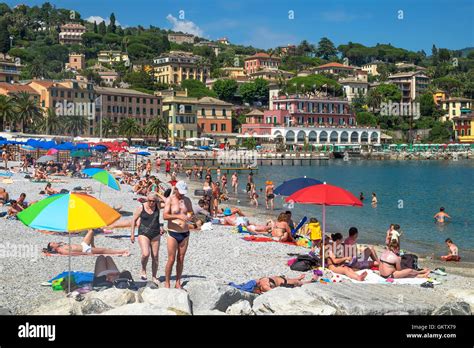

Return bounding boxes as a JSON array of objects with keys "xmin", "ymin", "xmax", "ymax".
[{"xmin": 153, "ymin": 51, "xmax": 211, "ymax": 85}]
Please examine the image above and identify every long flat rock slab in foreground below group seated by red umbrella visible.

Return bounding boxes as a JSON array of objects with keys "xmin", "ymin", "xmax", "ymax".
[{"xmin": 301, "ymin": 283, "xmax": 446, "ymax": 315}]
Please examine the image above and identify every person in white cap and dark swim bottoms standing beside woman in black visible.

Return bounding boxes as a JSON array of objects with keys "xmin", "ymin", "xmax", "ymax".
[{"xmin": 163, "ymin": 181, "xmax": 194, "ymax": 289}]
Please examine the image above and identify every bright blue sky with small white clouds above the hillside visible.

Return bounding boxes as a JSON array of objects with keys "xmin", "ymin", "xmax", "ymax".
[{"xmin": 6, "ymin": 0, "xmax": 474, "ymax": 54}]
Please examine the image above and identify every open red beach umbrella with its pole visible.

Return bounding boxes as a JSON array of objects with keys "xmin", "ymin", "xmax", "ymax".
[{"xmin": 286, "ymin": 183, "xmax": 363, "ymax": 268}]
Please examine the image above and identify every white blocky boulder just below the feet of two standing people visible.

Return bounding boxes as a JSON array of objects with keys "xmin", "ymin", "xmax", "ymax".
[{"xmin": 141, "ymin": 288, "xmax": 192, "ymax": 314}]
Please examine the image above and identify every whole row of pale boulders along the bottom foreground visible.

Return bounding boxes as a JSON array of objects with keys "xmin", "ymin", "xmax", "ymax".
[{"xmin": 32, "ymin": 280, "xmax": 474, "ymax": 315}]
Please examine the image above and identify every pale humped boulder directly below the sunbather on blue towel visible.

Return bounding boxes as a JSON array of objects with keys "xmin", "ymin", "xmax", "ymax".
[{"xmin": 252, "ymin": 288, "xmax": 336, "ymax": 315}]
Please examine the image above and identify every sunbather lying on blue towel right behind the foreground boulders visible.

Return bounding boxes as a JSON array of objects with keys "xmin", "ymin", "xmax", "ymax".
[{"xmin": 229, "ymin": 274, "xmax": 316, "ymax": 294}]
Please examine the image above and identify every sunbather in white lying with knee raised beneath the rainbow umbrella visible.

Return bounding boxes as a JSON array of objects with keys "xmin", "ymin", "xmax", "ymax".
[{"xmin": 45, "ymin": 230, "xmax": 130, "ymax": 256}]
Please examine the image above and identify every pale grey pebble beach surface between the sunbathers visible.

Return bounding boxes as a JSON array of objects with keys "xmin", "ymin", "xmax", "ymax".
[{"xmin": 0, "ymin": 166, "xmax": 474, "ymax": 314}]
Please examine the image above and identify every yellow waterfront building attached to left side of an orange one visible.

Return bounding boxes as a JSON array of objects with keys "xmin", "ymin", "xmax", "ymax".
[{"xmin": 156, "ymin": 90, "xmax": 198, "ymax": 146}]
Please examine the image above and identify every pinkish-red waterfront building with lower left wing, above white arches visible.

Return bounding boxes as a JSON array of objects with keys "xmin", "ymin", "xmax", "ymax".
[{"xmin": 242, "ymin": 96, "xmax": 356, "ymax": 134}]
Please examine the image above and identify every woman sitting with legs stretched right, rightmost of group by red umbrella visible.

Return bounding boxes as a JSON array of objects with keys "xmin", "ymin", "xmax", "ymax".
[{"xmin": 379, "ymin": 239, "xmax": 430, "ymax": 279}]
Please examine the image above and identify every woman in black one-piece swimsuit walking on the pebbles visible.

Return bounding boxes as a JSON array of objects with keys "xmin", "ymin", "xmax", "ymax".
[{"xmin": 130, "ymin": 192, "xmax": 164, "ymax": 284}]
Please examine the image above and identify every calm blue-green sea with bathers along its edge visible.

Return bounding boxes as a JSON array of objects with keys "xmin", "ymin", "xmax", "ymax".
[{"xmin": 235, "ymin": 160, "xmax": 474, "ymax": 260}]
